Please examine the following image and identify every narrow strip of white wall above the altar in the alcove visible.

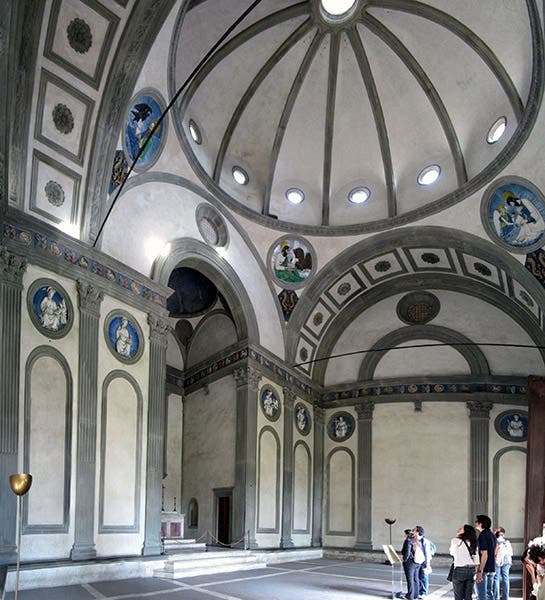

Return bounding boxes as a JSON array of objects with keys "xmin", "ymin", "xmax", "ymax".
[{"xmin": 163, "ymin": 394, "xmax": 185, "ymax": 512}]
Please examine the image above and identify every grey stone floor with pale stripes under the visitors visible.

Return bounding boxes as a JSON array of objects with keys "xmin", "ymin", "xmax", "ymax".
[{"xmin": 5, "ymin": 558, "xmax": 520, "ymax": 600}]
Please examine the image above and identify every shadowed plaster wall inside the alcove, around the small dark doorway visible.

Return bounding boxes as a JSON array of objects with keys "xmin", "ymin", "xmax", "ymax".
[{"xmin": 179, "ymin": 375, "xmax": 236, "ymax": 539}]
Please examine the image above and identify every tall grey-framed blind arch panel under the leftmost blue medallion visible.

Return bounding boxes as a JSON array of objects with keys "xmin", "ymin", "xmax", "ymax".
[{"xmin": 23, "ymin": 346, "xmax": 73, "ymax": 534}]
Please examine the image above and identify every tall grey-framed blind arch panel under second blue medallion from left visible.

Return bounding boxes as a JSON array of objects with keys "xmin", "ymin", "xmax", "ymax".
[{"xmin": 98, "ymin": 369, "xmax": 144, "ymax": 533}]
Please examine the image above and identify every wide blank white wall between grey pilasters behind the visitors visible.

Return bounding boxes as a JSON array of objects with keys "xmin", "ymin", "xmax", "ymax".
[{"xmin": 372, "ymin": 402, "xmax": 468, "ymax": 552}]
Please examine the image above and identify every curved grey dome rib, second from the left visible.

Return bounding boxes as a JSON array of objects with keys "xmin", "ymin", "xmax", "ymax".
[{"xmin": 213, "ymin": 19, "xmax": 312, "ymax": 183}]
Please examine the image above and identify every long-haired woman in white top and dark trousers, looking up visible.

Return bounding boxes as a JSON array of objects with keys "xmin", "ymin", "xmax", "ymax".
[{"xmin": 449, "ymin": 524, "xmax": 479, "ymax": 600}]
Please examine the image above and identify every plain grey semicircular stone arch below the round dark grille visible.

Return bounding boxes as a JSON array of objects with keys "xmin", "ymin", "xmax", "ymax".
[{"xmin": 358, "ymin": 325, "xmax": 490, "ymax": 381}]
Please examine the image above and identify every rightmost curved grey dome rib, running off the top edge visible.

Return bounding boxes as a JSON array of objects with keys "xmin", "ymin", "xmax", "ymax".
[{"xmin": 369, "ymin": 0, "xmax": 524, "ymax": 121}]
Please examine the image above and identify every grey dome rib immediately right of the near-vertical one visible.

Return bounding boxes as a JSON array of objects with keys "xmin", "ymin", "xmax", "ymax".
[{"xmin": 347, "ymin": 29, "xmax": 397, "ymax": 217}]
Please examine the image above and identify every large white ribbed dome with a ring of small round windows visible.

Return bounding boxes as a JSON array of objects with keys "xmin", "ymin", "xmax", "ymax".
[{"xmin": 169, "ymin": 0, "xmax": 543, "ymax": 234}]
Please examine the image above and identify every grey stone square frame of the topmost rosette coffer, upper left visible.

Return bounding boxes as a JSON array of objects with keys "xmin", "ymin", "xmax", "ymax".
[{"xmin": 44, "ymin": 0, "xmax": 119, "ymax": 90}]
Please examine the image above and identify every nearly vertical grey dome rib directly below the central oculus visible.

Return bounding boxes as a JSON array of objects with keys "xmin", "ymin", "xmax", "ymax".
[{"xmin": 322, "ymin": 31, "xmax": 341, "ymax": 225}]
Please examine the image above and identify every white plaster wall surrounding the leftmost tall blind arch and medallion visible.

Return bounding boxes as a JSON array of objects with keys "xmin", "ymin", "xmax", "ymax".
[{"xmin": 18, "ymin": 264, "xmax": 79, "ymax": 561}]
